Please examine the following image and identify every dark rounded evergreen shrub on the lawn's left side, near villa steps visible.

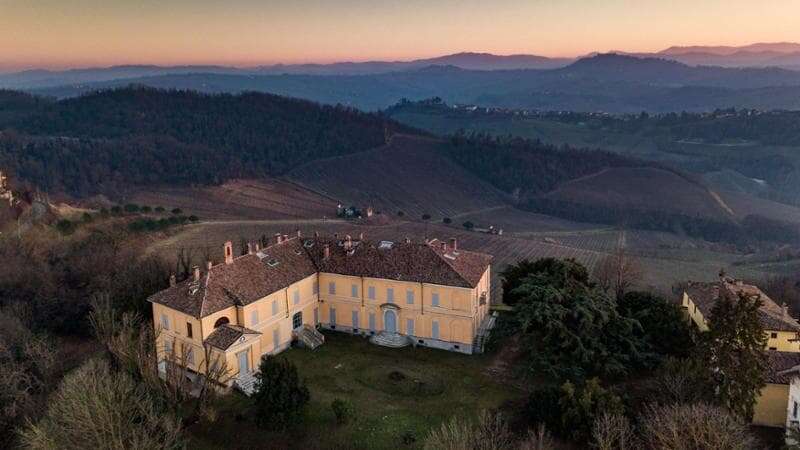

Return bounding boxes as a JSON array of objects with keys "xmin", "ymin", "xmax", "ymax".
[{"xmin": 253, "ymin": 356, "xmax": 311, "ymax": 430}]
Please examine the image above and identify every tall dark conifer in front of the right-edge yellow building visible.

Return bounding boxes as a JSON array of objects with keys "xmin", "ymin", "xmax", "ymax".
[{"xmin": 701, "ymin": 294, "xmax": 767, "ymax": 421}]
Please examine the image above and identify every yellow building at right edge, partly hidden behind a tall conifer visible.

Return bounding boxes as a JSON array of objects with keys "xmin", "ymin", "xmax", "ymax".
[{"xmin": 681, "ymin": 275, "xmax": 800, "ymax": 427}]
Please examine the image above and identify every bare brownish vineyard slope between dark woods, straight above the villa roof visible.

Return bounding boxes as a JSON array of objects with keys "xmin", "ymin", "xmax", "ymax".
[{"xmin": 287, "ymin": 135, "xmax": 507, "ymax": 220}]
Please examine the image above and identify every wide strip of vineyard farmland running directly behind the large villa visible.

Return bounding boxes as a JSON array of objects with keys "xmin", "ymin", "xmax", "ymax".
[{"xmin": 152, "ymin": 209, "xmax": 771, "ymax": 299}]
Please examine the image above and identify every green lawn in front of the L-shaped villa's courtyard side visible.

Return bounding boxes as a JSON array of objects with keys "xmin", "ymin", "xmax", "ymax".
[{"xmin": 189, "ymin": 332, "xmax": 521, "ymax": 449}]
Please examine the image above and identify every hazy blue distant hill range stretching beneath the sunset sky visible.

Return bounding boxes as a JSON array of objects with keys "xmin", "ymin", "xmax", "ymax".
[{"xmin": 17, "ymin": 54, "xmax": 800, "ymax": 112}]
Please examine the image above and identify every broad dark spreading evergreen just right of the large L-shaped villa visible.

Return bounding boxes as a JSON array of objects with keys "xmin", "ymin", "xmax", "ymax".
[{"xmin": 512, "ymin": 258, "xmax": 651, "ymax": 379}]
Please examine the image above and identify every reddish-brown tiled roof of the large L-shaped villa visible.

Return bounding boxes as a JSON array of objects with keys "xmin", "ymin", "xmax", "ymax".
[{"xmin": 148, "ymin": 237, "xmax": 492, "ymax": 318}]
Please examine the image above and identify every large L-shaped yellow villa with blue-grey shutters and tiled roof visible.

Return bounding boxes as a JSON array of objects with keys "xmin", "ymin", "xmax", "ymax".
[{"xmin": 149, "ymin": 232, "xmax": 493, "ymax": 392}]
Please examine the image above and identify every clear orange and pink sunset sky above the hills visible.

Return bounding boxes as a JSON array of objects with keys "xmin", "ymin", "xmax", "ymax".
[{"xmin": 0, "ymin": 0, "xmax": 800, "ymax": 70}]
